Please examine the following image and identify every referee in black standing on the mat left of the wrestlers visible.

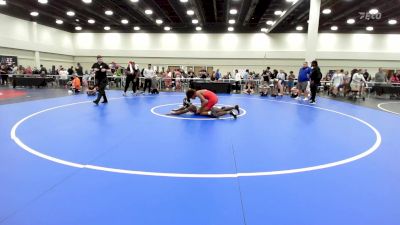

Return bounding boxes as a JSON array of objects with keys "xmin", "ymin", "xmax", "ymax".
[{"xmin": 92, "ymin": 56, "xmax": 110, "ymax": 105}]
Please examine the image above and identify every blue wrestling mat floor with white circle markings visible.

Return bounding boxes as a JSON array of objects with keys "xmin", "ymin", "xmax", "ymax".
[{"xmin": 0, "ymin": 89, "xmax": 400, "ymax": 225}]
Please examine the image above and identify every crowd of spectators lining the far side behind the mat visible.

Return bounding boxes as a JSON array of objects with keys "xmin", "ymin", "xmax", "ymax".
[{"xmin": 0, "ymin": 62, "xmax": 400, "ymax": 100}]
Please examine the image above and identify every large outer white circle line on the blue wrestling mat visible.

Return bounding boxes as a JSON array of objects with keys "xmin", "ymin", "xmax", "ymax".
[{"xmin": 10, "ymin": 97, "xmax": 382, "ymax": 178}]
